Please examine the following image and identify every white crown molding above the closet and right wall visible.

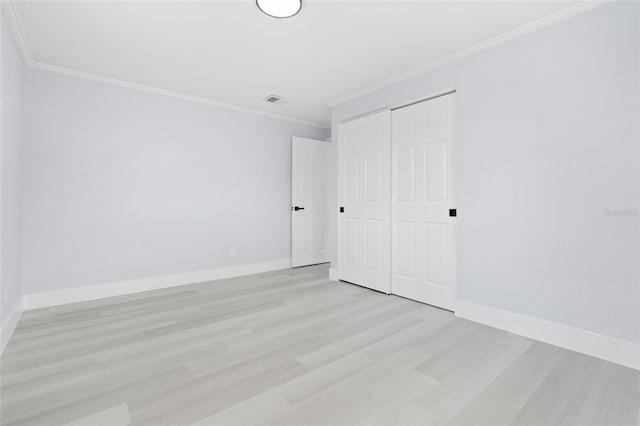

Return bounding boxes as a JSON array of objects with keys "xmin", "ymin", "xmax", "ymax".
[{"xmin": 328, "ymin": 0, "xmax": 613, "ymax": 108}]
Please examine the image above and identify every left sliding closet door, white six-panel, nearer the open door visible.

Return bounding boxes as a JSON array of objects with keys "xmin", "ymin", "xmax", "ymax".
[{"xmin": 338, "ymin": 111, "xmax": 391, "ymax": 293}]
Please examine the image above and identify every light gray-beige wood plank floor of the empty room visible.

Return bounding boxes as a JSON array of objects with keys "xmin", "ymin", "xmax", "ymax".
[{"xmin": 0, "ymin": 265, "xmax": 640, "ymax": 426}]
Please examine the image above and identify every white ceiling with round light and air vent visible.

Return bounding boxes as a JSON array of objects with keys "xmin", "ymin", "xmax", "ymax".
[{"xmin": 12, "ymin": 0, "xmax": 577, "ymax": 125}]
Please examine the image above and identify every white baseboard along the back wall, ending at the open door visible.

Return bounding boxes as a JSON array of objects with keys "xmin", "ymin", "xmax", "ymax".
[{"xmin": 23, "ymin": 258, "xmax": 291, "ymax": 310}]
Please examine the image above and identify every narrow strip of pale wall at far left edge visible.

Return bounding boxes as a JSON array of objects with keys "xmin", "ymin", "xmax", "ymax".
[{"xmin": 0, "ymin": 8, "xmax": 24, "ymax": 325}]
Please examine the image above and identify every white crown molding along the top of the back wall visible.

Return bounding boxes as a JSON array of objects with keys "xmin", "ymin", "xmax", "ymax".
[{"xmin": 27, "ymin": 61, "xmax": 329, "ymax": 129}]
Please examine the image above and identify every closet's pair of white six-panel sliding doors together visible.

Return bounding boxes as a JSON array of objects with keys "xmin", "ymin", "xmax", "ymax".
[{"xmin": 338, "ymin": 93, "xmax": 456, "ymax": 310}]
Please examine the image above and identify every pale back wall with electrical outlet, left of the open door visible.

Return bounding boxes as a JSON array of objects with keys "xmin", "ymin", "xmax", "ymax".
[{"xmin": 23, "ymin": 69, "xmax": 327, "ymax": 293}]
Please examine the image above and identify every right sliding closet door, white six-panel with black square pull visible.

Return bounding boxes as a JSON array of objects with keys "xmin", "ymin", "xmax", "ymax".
[{"xmin": 392, "ymin": 94, "xmax": 456, "ymax": 310}]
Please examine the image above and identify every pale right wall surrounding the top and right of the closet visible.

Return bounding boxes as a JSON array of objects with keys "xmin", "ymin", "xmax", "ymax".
[{"xmin": 333, "ymin": 2, "xmax": 640, "ymax": 342}]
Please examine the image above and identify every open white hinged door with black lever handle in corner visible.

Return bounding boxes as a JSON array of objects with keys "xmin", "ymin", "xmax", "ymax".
[{"xmin": 291, "ymin": 137, "xmax": 331, "ymax": 267}]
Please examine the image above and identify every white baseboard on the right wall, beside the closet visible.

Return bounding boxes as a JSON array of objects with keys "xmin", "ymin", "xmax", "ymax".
[{"xmin": 456, "ymin": 300, "xmax": 640, "ymax": 370}]
